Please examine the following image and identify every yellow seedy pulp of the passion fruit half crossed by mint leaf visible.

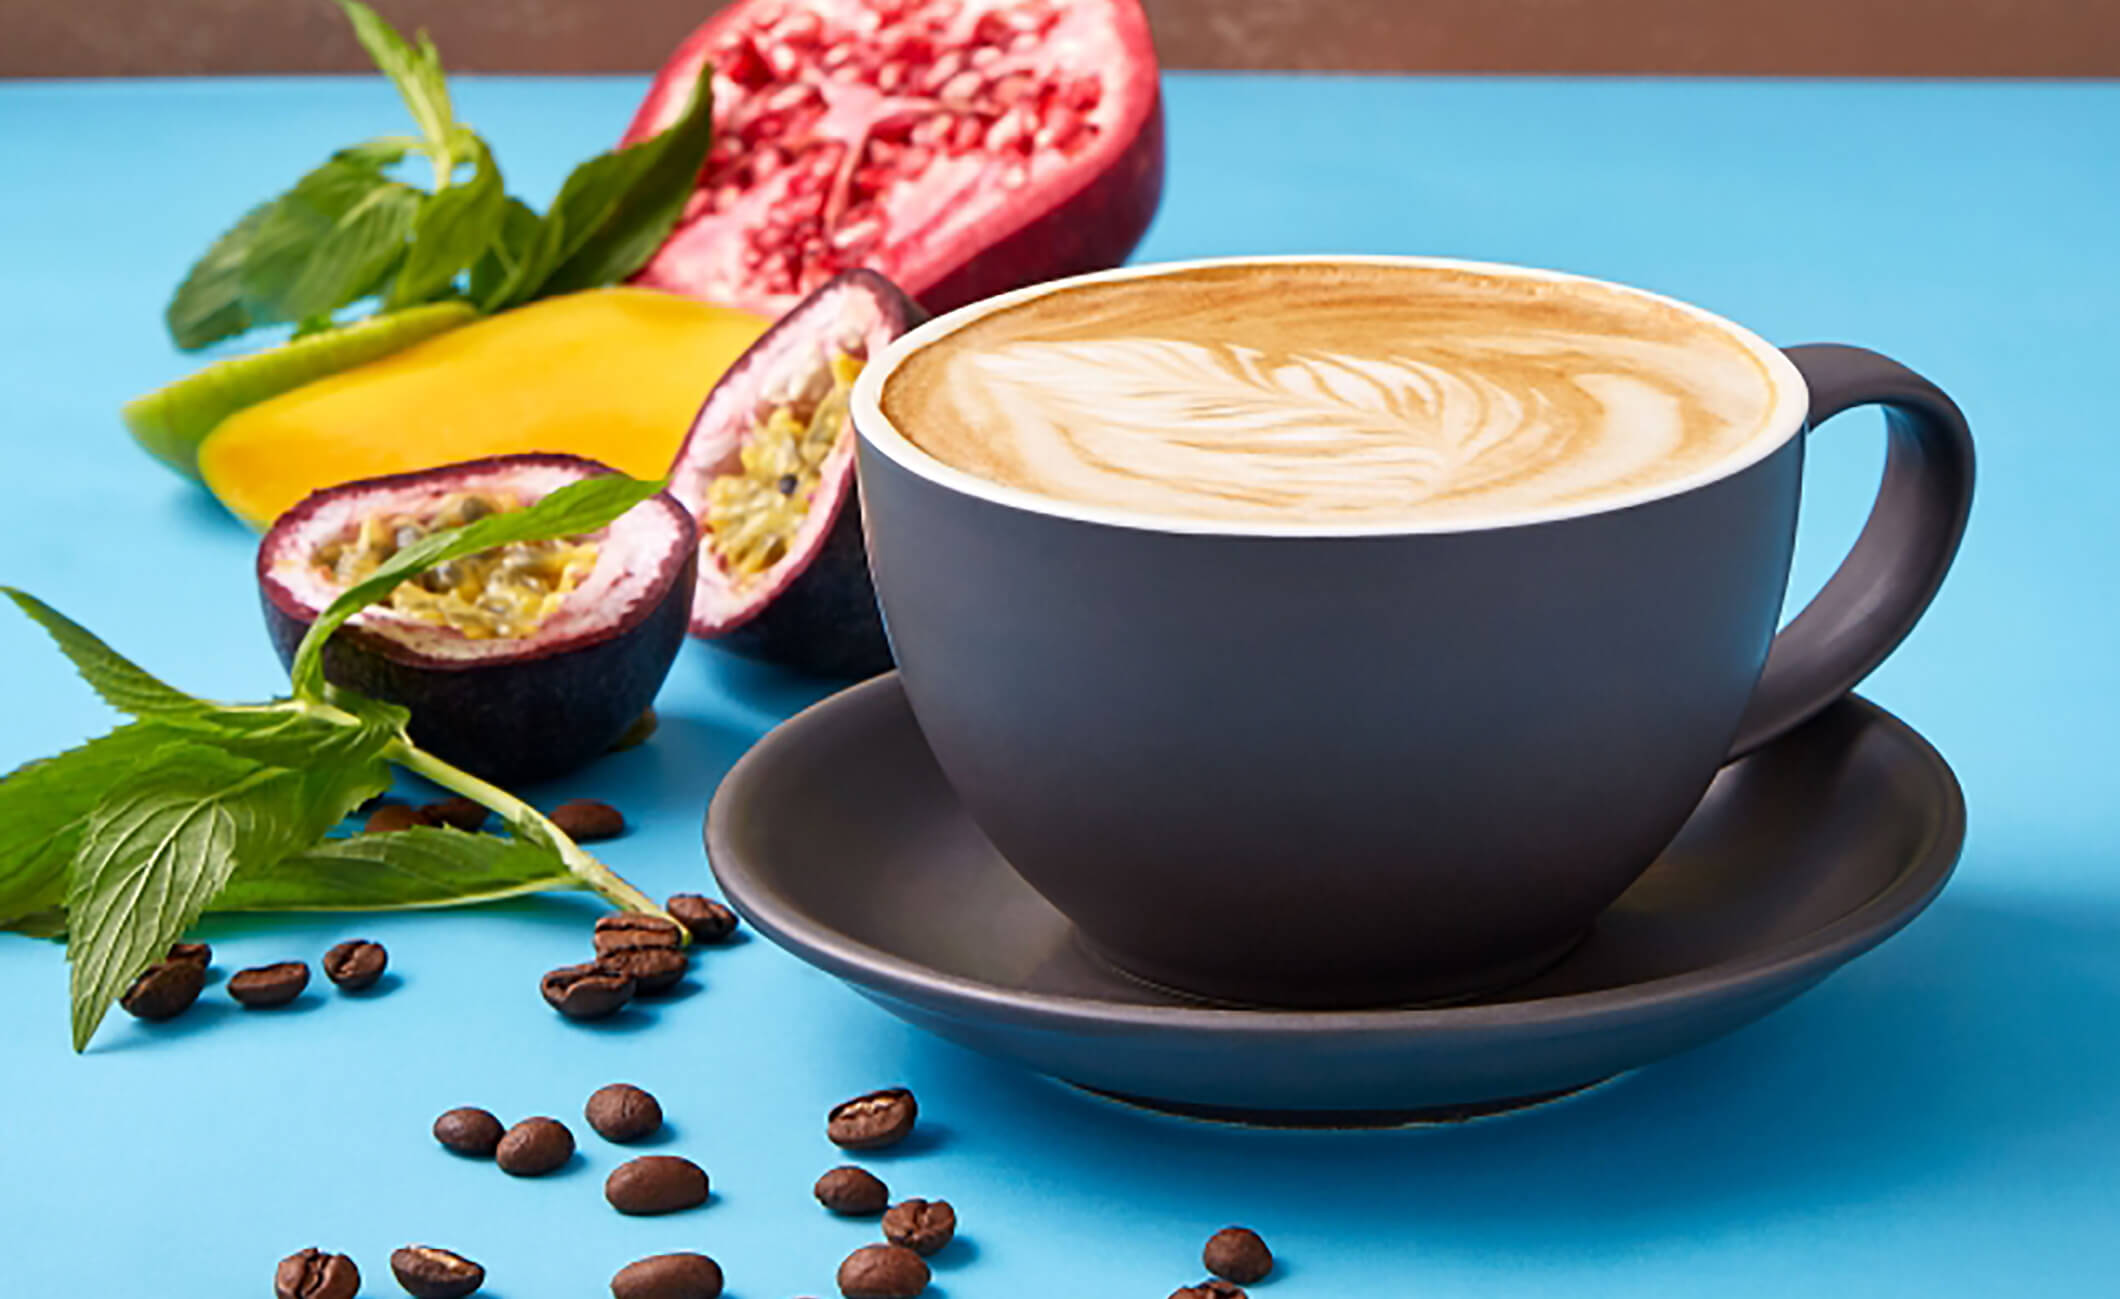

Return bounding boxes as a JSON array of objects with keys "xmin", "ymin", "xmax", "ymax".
[{"xmin": 314, "ymin": 492, "xmax": 596, "ymax": 640}]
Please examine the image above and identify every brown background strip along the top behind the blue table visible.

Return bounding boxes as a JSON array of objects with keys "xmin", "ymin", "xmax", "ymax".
[{"xmin": 0, "ymin": 0, "xmax": 2120, "ymax": 76}]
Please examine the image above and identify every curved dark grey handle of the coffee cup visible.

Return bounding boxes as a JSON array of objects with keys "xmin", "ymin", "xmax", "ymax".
[{"xmin": 1726, "ymin": 343, "xmax": 1974, "ymax": 761}]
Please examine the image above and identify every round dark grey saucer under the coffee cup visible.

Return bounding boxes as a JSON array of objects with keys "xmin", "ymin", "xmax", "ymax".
[{"xmin": 706, "ymin": 676, "xmax": 1965, "ymax": 1125}]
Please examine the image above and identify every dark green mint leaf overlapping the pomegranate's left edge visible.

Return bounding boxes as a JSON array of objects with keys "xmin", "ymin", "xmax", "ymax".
[{"xmin": 526, "ymin": 61, "xmax": 714, "ymax": 299}]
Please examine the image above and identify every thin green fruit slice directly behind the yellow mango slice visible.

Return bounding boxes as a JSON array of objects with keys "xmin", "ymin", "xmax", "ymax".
[{"xmin": 123, "ymin": 303, "xmax": 479, "ymax": 479}]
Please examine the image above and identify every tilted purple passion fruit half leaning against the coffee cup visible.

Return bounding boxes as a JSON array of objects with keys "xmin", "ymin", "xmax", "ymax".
[{"xmin": 670, "ymin": 271, "xmax": 926, "ymax": 678}]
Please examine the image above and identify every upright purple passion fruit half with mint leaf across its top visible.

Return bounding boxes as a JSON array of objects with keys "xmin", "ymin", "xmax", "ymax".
[{"xmin": 257, "ymin": 453, "xmax": 700, "ymax": 784}]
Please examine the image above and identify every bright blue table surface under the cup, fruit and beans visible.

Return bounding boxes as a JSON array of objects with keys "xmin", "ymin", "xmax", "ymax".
[{"xmin": 0, "ymin": 74, "xmax": 2120, "ymax": 1299}]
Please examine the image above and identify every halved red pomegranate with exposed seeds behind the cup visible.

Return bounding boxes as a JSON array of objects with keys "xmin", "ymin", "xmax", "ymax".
[{"xmin": 625, "ymin": 0, "xmax": 1164, "ymax": 316}]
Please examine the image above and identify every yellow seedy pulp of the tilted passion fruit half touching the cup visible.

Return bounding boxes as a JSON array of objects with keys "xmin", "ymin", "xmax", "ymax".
[{"xmin": 702, "ymin": 339, "xmax": 867, "ymax": 581}]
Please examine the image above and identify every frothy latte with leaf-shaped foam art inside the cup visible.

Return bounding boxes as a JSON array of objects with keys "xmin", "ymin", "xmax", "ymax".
[{"xmin": 882, "ymin": 263, "xmax": 1774, "ymax": 526}]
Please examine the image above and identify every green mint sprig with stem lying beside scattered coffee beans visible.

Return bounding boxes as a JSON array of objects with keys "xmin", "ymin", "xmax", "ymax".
[{"xmin": 0, "ymin": 475, "xmax": 661, "ymax": 1051}]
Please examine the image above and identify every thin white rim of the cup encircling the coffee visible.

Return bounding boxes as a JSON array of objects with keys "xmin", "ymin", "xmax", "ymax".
[{"xmin": 850, "ymin": 252, "xmax": 1810, "ymax": 536}]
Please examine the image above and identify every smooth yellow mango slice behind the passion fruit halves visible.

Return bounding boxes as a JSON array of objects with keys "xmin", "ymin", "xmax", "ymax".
[{"xmin": 199, "ymin": 288, "xmax": 772, "ymax": 528}]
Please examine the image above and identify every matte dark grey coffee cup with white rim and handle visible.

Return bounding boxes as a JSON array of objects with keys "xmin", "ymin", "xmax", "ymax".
[{"xmin": 854, "ymin": 259, "xmax": 1974, "ymax": 1007}]
